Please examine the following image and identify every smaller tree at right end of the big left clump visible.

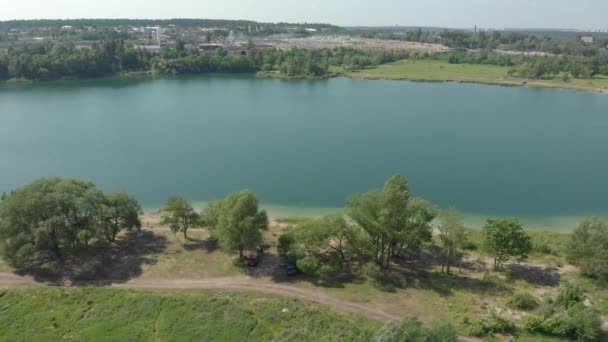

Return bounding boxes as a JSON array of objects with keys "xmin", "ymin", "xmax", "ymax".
[{"xmin": 99, "ymin": 192, "xmax": 143, "ymax": 242}]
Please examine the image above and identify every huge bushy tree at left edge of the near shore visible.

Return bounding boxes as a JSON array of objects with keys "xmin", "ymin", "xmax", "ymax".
[{"xmin": 0, "ymin": 178, "xmax": 104, "ymax": 267}]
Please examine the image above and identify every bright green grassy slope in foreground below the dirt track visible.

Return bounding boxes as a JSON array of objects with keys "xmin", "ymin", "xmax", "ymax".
[{"xmin": 0, "ymin": 288, "xmax": 379, "ymax": 341}]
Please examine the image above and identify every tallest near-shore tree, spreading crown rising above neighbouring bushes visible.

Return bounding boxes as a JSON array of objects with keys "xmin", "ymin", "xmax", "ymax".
[{"xmin": 346, "ymin": 175, "xmax": 435, "ymax": 267}]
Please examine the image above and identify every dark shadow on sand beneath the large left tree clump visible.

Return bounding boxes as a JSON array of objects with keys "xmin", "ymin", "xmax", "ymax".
[{"xmin": 15, "ymin": 231, "xmax": 167, "ymax": 286}]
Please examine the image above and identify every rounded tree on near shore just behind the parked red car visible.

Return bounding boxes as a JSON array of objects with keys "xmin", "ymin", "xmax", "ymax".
[{"xmin": 203, "ymin": 190, "xmax": 268, "ymax": 258}]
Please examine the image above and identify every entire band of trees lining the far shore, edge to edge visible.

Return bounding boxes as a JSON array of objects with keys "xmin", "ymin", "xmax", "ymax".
[{"xmin": 0, "ymin": 40, "xmax": 608, "ymax": 81}]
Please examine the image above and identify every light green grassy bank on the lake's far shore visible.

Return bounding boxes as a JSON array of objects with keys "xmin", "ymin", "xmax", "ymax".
[{"xmin": 333, "ymin": 60, "xmax": 608, "ymax": 92}]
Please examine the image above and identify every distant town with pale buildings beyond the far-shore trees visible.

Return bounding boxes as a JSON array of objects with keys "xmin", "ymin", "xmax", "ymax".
[{"xmin": 0, "ymin": 19, "xmax": 608, "ymax": 55}]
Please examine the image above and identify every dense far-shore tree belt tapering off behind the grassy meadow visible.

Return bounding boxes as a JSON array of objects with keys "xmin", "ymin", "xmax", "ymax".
[{"xmin": 0, "ymin": 40, "xmax": 407, "ymax": 81}]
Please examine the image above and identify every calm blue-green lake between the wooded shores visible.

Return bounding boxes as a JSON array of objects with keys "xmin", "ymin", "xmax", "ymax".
[{"xmin": 0, "ymin": 75, "xmax": 608, "ymax": 229}]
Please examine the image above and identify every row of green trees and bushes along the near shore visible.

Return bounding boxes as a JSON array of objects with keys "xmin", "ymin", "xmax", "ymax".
[{"xmin": 0, "ymin": 175, "xmax": 608, "ymax": 277}]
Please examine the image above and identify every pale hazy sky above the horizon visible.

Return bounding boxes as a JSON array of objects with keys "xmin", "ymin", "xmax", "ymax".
[{"xmin": 0, "ymin": 0, "xmax": 608, "ymax": 29}]
